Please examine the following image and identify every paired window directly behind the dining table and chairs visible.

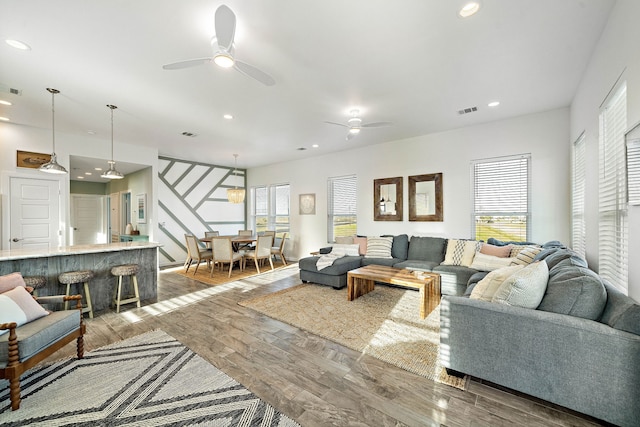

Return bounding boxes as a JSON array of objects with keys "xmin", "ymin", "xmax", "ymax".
[{"xmin": 250, "ymin": 184, "xmax": 290, "ymax": 233}]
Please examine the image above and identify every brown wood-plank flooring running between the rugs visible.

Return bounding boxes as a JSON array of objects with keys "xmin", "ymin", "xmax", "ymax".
[{"xmin": 37, "ymin": 265, "xmax": 603, "ymax": 426}]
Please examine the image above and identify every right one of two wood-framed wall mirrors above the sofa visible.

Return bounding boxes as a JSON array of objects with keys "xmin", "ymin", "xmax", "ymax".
[{"xmin": 409, "ymin": 173, "xmax": 443, "ymax": 221}]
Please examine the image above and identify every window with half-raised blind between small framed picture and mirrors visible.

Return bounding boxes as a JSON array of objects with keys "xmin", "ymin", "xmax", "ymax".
[{"xmin": 327, "ymin": 175, "xmax": 357, "ymax": 242}]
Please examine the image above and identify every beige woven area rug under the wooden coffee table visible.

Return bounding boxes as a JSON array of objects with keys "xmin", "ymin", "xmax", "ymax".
[{"xmin": 238, "ymin": 284, "xmax": 468, "ymax": 390}]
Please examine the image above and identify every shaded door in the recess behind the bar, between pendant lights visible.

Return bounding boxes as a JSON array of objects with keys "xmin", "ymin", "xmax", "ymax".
[{"xmin": 70, "ymin": 194, "xmax": 108, "ymax": 245}]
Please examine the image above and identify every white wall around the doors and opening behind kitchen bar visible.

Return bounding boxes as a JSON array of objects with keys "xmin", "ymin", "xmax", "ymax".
[{"xmin": 0, "ymin": 122, "xmax": 158, "ymax": 249}]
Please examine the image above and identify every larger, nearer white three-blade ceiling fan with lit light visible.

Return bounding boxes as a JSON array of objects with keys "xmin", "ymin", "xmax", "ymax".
[{"xmin": 162, "ymin": 5, "xmax": 276, "ymax": 86}]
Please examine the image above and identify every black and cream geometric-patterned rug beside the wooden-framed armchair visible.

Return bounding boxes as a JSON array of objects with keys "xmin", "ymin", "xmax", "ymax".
[{"xmin": 0, "ymin": 331, "xmax": 298, "ymax": 427}]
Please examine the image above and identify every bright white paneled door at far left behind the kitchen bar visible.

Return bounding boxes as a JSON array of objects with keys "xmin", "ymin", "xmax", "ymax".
[{"xmin": 9, "ymin": 177, "xmax": 62, "ymax": 250}]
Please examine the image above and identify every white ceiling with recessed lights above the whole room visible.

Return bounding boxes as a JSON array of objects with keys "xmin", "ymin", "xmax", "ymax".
[{"xmin": 0, "ymin": 0, "xmax": 614, "ymax": 174}]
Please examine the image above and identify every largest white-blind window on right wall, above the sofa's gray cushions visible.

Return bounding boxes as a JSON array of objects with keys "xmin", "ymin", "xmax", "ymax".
[{"xmin": 598, "ymin": 84, "xmax": 628, "ymax": 293}]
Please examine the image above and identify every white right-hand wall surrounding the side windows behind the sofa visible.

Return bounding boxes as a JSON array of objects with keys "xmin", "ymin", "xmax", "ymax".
[{"xmin": 570, "ymin": 0, "xmax": 640, "ymax": 301}]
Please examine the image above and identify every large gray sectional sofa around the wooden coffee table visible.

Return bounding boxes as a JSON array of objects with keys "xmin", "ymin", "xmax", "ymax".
[{"xmin": 299, "ymin": 235, "xmax": 640, "ymax": 426}]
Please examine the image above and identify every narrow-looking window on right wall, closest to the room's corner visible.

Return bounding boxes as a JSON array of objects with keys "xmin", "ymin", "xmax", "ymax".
[{"xmin": 571, "ymin": 134, "xmax": 586, "ymax": 258}]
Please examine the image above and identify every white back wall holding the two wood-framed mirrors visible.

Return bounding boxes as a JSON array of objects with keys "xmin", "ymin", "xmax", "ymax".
[{"xmin": 247, "ymin": 108, "xmax": 570, "ymax": 259}]
